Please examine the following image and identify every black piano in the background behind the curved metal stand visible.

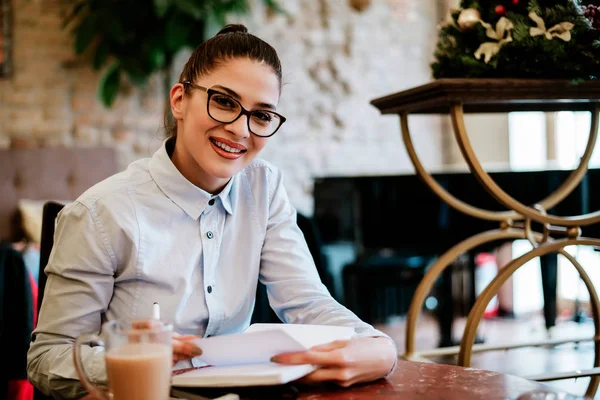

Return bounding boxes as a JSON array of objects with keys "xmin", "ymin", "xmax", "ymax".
[{"xmin": 314, "ymin": 169, "xmax": 600, "ymax": 345}]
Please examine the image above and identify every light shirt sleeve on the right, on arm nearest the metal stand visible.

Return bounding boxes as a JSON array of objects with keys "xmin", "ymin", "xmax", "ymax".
[{"xmin": 260, "ymin": 168, "xmax": 396, "ymax": 368}]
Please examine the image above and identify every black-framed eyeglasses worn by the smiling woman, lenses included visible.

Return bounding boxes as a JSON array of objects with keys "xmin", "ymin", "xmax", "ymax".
[{"xmin": 181, "ymin": 81, "xmax": 285, "ymax": 137}]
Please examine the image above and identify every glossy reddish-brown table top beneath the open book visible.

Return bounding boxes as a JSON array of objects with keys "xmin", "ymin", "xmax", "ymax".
[{"xmin": 169, "ymin": 361, "xmax": 583, "ymax": 400}]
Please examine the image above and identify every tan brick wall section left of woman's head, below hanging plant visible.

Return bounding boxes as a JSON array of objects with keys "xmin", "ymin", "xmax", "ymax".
[{"xmin": 0, "ymin": 0, "xmax": 163, "ymax": 154}]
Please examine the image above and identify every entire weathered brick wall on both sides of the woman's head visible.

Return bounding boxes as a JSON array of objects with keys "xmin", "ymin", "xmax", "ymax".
[{"xmin": 0, "ymin": 0, "xmax": 442, "ymax": 213}]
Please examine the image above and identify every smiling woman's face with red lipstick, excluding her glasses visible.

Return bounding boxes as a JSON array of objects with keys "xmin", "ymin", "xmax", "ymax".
[{"xmin": 170, "ymin": 58, "xmax": 280, "ymax": 193}]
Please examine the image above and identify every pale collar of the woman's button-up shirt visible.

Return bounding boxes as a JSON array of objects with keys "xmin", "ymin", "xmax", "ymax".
[{"xmin": 149, "ymin": 138, "xmax": 235, "ymax": 219}]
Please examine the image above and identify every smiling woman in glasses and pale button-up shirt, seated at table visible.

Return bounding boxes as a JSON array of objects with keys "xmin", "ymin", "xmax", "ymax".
[{"xmin": 27, "ymin": 25, "xmax": 397, "ymax": 400}]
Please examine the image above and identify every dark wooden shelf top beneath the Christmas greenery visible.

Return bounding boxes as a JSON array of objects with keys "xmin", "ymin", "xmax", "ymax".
[{"xmin": 371, "ymin": 79, "xmax": 600, "ymax": 114}]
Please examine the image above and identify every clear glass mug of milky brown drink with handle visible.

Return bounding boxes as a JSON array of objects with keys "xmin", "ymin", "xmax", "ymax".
[{"xmin": 73, "ymin": 320, "xmax": 173, "ymax": 400}]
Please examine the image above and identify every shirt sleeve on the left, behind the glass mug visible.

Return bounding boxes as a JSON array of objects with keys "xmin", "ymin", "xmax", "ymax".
[{"xmin": 27, "ymin": 202, "xmax": 116, "ymax": 398}]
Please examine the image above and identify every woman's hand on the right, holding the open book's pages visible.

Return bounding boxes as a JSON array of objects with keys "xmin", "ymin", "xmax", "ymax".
[{"xmin": 271, "ymin": 337, "xmax": 398, "ymax": 387}]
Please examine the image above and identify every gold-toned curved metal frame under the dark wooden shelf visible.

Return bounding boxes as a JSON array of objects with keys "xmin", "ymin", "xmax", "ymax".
[{"xmin": 400, "ymin": 103, "xmax": 600, "ymax": 397}]
